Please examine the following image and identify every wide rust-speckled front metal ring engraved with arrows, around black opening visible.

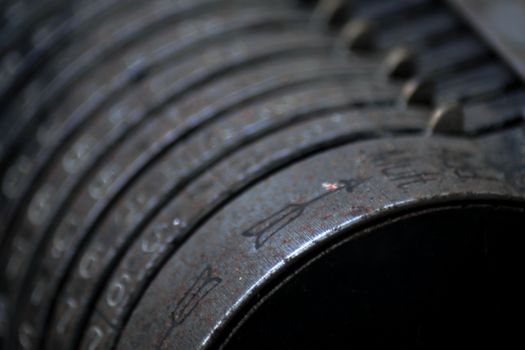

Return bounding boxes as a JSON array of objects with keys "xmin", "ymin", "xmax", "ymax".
[{"xmin": 118, "ymin": 130, "xmax": 525, "ymax": 349}]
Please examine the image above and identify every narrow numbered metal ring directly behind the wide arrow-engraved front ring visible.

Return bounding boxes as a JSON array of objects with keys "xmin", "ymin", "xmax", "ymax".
[{"xmin": 79, "ymin": 107, "xmax": 424, "ymax": 348}]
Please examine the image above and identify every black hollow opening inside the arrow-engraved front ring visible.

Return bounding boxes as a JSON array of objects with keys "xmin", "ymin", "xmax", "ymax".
[{"xmin": 223, "ymin": 206, "xmax": 525, "ymax": 349}]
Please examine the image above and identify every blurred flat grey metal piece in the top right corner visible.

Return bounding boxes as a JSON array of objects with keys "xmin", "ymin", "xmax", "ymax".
[{"xmin": 448, "ymin": 0, "xmax": 525, "ymax": 79}]
